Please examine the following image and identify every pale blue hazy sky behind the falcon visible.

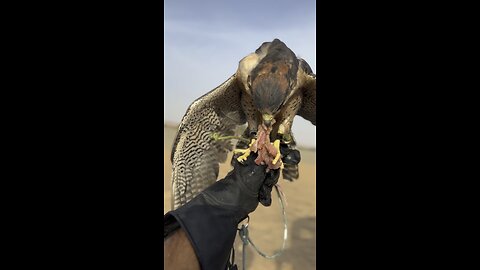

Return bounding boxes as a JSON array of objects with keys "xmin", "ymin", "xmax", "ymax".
[{"xmin": 164, "ymin": 0, "xmax": 317, "ymax": 147}]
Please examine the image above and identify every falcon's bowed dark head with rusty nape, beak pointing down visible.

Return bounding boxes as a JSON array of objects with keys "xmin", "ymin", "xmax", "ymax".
[{"xmin": 242, "ymin": 39, "xmax": 298, "ymax": 127}]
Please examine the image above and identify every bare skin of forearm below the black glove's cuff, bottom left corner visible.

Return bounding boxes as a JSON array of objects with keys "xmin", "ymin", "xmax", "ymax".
[{"xmin": 163, "ymin": 228, "xmax": 200, "ymax": 270}]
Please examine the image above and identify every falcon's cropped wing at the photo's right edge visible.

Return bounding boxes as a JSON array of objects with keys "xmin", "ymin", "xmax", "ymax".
[{"xmin": 297, "ymin": 59, "xmax": 317, "ymax": 126}]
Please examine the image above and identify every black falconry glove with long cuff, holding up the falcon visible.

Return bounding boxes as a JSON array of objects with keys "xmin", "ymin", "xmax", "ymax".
[{"xmin": 164, "ymin": 153, "xmax": 280, "ymax": 270}]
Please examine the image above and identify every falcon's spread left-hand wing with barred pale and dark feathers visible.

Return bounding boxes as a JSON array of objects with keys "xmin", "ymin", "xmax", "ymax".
[{"xmin": 171, "ymin": 75, "xmax": 246, "ymax": 209}]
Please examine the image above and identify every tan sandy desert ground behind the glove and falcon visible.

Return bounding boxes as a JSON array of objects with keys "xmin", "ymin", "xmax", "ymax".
[{"xmin": 164, "ymin": 126, "xmax": 316, "ymax": 270}]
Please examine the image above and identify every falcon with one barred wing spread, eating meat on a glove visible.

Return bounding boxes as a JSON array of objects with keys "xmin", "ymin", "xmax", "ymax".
[{"xmin": 170, "ymin": 39, "xmax": 316, "ymax": 209}]
